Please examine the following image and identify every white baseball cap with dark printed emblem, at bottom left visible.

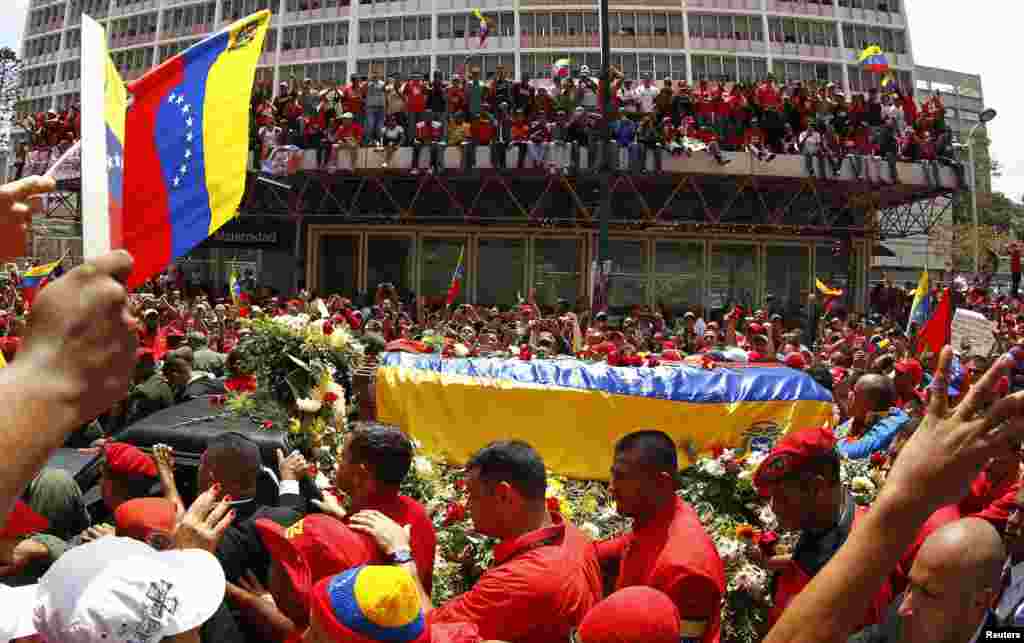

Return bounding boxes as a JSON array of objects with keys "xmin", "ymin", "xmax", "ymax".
[{"xmin": 34, "ymin": 537, "xmax": 225, "ymax": 643}]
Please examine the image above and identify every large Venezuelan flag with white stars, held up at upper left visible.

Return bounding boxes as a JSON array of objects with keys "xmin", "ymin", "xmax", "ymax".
[{"xmin": 122, "ymin": 11, "xmax": 270, "ymax": 288}]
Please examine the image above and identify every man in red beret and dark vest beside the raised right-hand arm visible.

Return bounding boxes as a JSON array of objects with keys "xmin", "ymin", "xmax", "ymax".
[{"xmin": 754, "ymin": 428, "xmax": 892, "ymax": 629}]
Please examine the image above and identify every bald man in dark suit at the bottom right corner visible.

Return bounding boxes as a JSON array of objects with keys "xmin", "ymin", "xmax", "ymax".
[{"xmin": 847, "ymin": 518, "xmax": 1007, "ymax": 643}]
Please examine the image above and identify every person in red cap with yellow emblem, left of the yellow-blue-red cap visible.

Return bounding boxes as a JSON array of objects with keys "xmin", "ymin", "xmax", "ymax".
[{"xmin": 227, "ymin": 514, "xmax": 385, "ymax": 641}]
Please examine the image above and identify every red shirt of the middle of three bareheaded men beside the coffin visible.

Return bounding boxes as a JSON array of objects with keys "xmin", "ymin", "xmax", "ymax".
[{"xmin": 430, "ymin": 514, "xmax": 602, "ymax": 643}]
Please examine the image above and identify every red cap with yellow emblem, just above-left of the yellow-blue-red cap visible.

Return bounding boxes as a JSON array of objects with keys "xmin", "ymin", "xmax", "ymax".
[{"xmin": 255, "ymin": 514, "xmax": 381, "ymax": 607}]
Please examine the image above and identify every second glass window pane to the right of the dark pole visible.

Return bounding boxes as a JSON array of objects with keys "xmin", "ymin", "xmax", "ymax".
[{"xmin": 654, "ymin": 241, "xmax": 705, "ymax": 315}]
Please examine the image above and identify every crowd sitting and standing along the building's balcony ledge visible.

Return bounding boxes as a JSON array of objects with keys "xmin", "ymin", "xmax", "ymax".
[{"xmin": 252, "ymin": 70, "xmax": 964, "ymax": 184}]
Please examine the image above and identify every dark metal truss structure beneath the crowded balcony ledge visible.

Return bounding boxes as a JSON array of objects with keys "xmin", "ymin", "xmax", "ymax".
[{"xmin": 242, "ymin": 170, "xmax": 952, "ymax": 238}]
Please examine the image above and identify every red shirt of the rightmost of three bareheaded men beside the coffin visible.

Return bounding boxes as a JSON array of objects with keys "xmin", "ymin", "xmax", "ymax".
[{"xmin": 596, "ymin": 497, "xmax": 725, "ymax": 643}]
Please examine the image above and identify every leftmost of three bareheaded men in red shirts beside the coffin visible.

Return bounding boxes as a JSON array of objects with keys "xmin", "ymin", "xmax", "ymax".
[{"xmin": 319, "ymin": 424, "xmax": 437, "ymax": 593}]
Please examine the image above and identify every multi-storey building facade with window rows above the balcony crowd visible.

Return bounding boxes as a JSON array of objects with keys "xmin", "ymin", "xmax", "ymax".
[{"xmin": 22, "ymin": 0, "xmax": 914, "ymax": 112}]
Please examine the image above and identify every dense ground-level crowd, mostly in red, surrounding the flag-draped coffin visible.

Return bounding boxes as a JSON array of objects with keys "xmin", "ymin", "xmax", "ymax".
[{"xmin": 0, "ymin": 170, "xmax": 1024, "ymax": 643}]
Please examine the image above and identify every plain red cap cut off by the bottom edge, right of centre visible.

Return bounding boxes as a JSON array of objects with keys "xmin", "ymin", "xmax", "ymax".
[{"xmin": 577, "ymin": 586, "xmax": 682, "ymax": 643}]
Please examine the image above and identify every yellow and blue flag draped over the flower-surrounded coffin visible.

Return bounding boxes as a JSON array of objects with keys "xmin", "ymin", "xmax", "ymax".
[{"xmin": 377, "ymin": 352, "xmax": 833, "ymax": 480}]
